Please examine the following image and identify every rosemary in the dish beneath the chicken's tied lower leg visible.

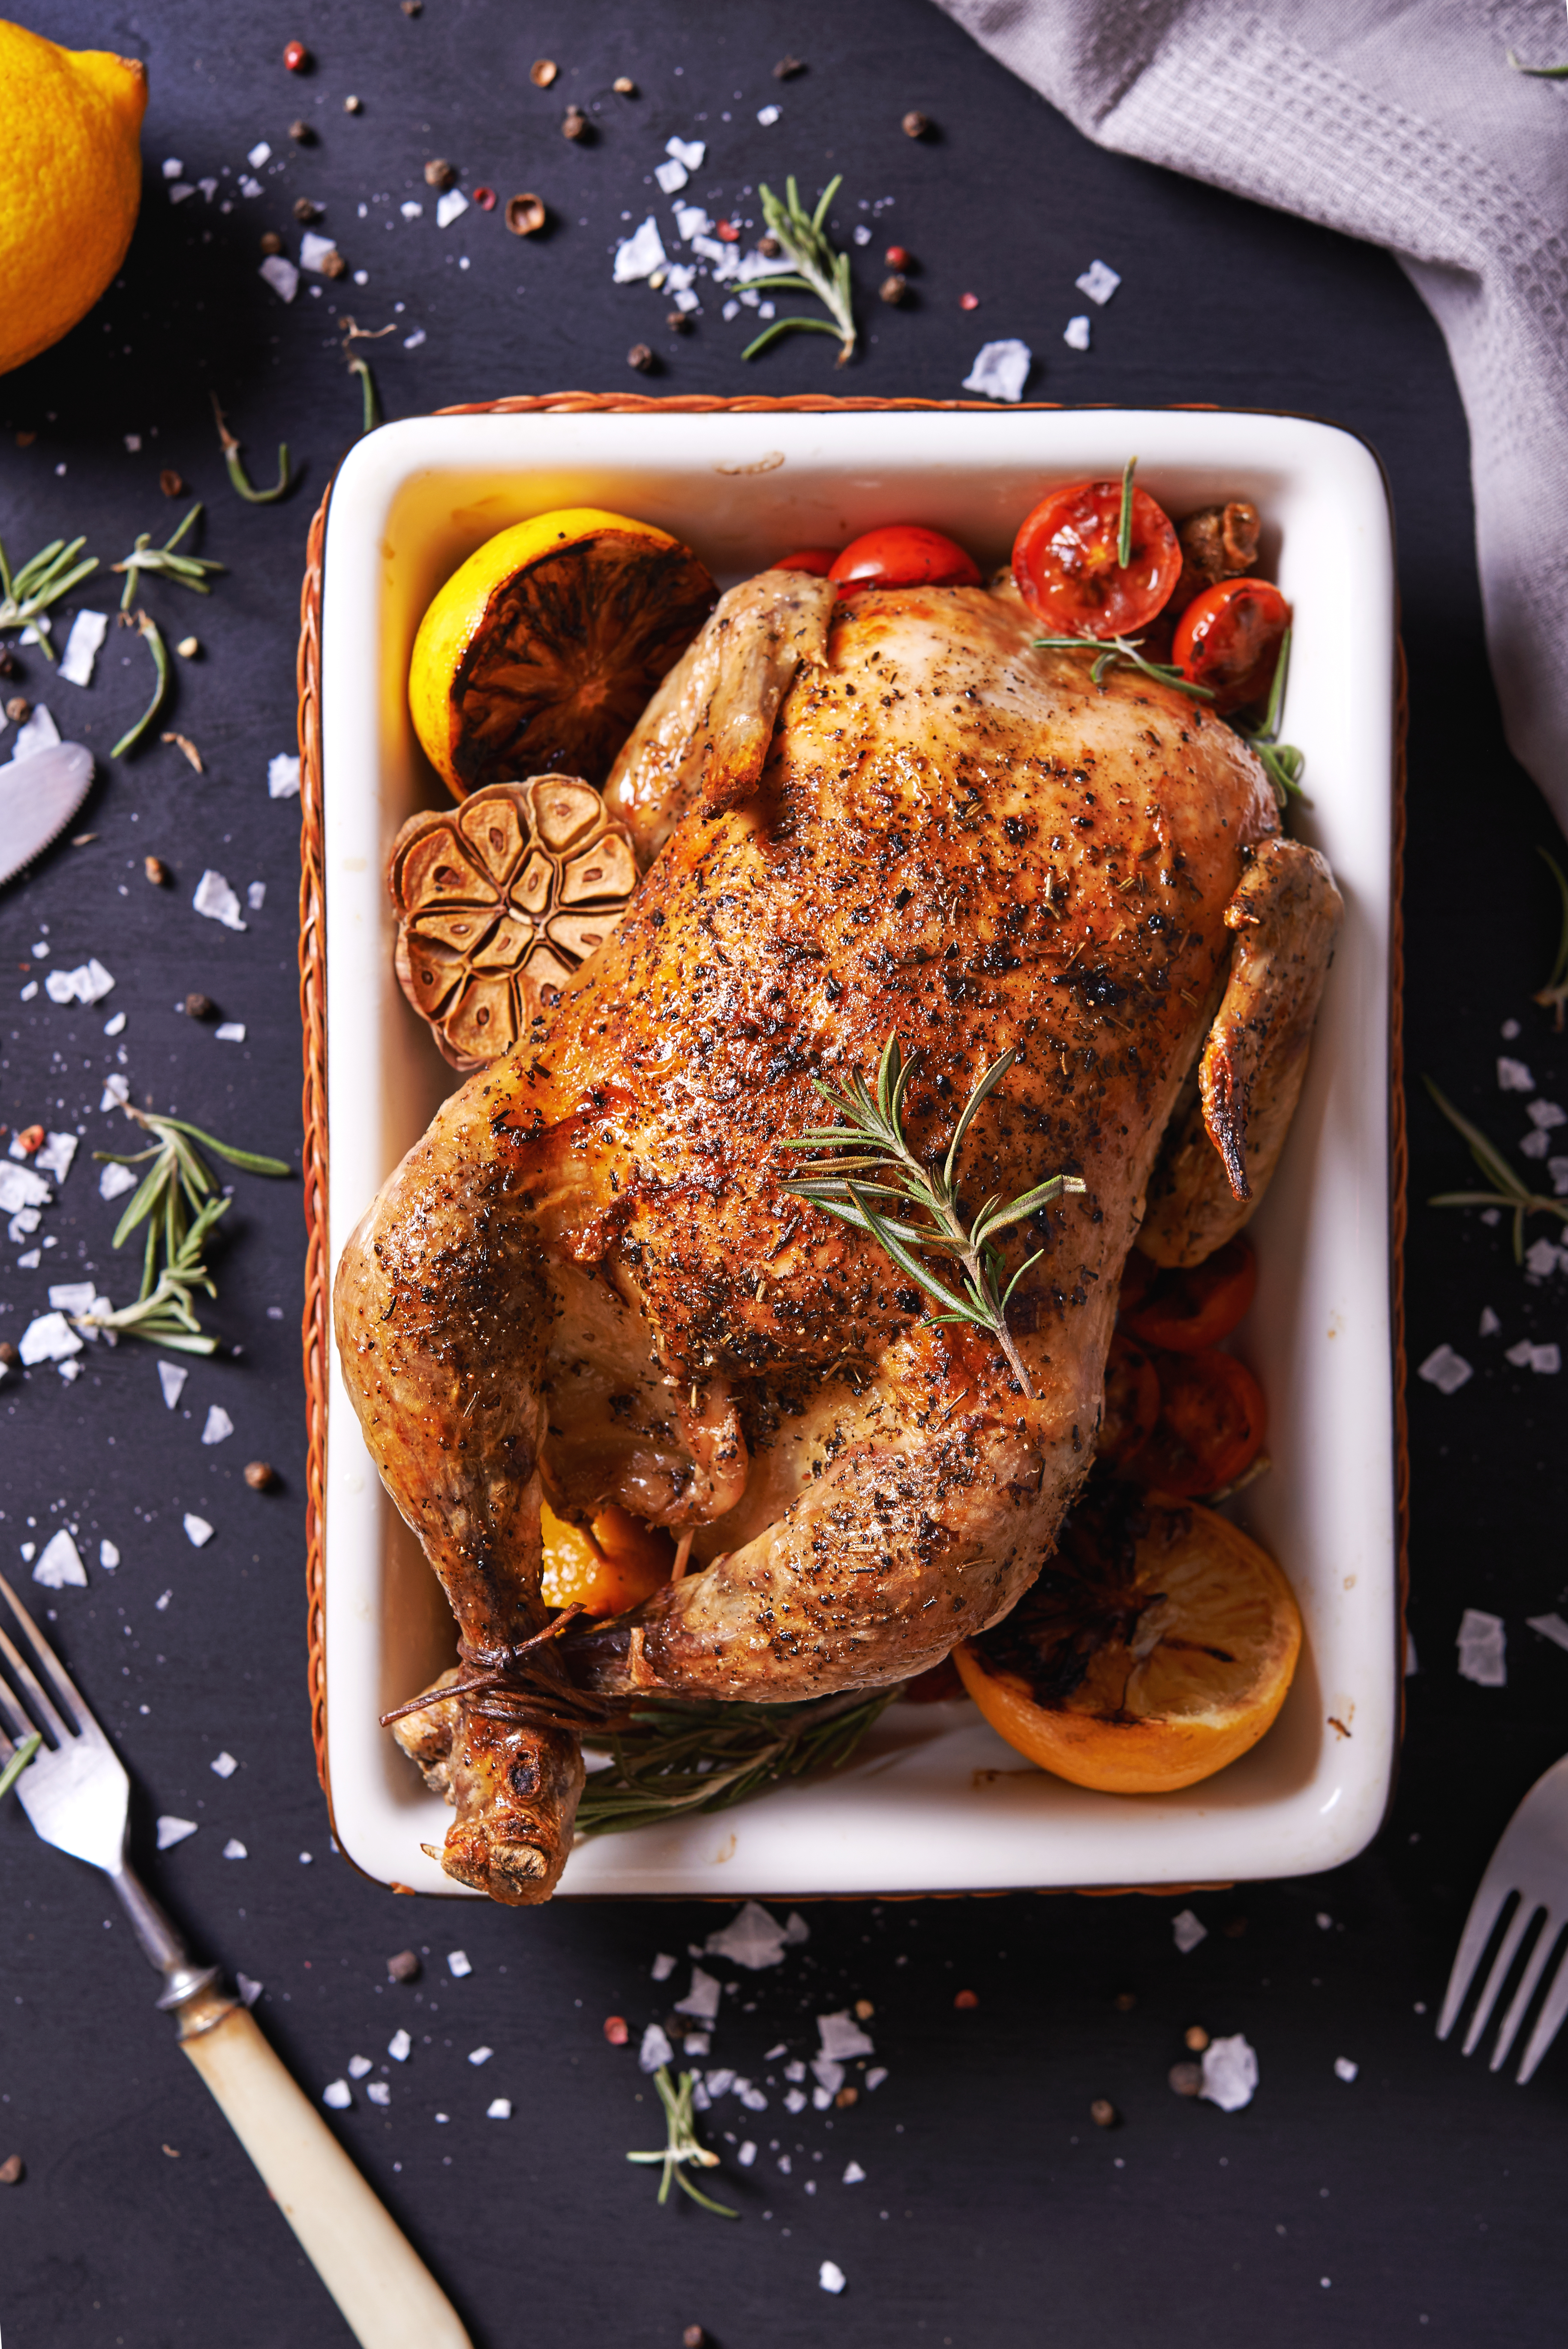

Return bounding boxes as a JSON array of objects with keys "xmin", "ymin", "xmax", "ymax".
[{"xmin": 577, "ymin": 1689, "xmax": 897, "ymax": 1835}]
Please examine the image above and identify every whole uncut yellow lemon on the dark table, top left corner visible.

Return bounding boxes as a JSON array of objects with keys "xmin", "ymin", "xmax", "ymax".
[{"xmin": 0, "ymin": 21, "xmax": 148, "ymax": 376}]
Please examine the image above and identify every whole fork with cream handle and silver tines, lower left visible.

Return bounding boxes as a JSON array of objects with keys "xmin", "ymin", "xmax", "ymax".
[{"xmin": 0, "ymin": 1574, "xmax": 469, "ymax": 2349}]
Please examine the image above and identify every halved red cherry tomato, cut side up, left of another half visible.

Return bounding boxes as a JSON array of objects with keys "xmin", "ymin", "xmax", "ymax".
[{"xmin": 1012, "ymin": 481, "xmax": 1181, "ymax": 637}]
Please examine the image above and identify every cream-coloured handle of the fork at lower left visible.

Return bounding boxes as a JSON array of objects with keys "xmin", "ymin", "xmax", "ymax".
[{"xmin": 181, "ymin": 1999, "xmax": 472, "ymax": 2349}]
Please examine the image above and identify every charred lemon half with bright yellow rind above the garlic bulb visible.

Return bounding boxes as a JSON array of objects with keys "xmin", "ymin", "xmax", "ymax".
[{"xmin": 409, "ymin": 505, "xmax": 718, "ymax": 799}]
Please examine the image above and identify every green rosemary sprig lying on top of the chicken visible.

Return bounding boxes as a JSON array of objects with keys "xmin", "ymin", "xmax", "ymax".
[{"xmin": 779, "ymin": 1036, "xmax": 1087, "ymax": 1400}]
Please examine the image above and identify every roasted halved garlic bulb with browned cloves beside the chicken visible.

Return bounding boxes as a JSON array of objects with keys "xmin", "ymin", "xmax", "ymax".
[{"xmin": 387, "ymin": 775, "xmax": 636, "ymax": 1069}]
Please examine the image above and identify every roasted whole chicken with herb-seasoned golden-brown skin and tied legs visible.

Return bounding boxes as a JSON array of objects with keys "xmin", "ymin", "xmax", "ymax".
[{"xmin": 336, "ymin": 571, "xmax": 1340, "ymax": 1903}]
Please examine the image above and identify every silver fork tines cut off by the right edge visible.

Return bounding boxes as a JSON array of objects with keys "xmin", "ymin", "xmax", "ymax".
[{"xmin": 1436, "ymin": 1755, "xmax": 1568, "ymax": 2088}]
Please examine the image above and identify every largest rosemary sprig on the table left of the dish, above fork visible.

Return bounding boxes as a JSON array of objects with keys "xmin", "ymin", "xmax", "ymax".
[{"xmin": 78, "ymin": 1102, "xmax": 289, "ymax": 1353}]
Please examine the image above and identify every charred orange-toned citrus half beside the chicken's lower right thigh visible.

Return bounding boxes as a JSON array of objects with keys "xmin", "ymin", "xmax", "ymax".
[{"xmin": 953, "ymin": 1492, "xmax": 1301, "ymax": 1795}]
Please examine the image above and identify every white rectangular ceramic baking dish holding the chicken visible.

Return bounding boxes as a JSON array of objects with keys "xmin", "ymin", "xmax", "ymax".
[{"xmin": 319, "ymin": 409, "xmax": 1401, "ymax": 1898}]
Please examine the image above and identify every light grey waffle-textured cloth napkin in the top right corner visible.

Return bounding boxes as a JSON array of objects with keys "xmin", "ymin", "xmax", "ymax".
[{"xmin": 937, "ymin": 0, "xmax": 1568, "ymax": 829}]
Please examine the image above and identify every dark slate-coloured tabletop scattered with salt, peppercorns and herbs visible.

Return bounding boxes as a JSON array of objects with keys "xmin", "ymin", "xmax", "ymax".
[{"xmin": 0, "ymin": 0, "xmax": 1568, "ymax": 2349}]
